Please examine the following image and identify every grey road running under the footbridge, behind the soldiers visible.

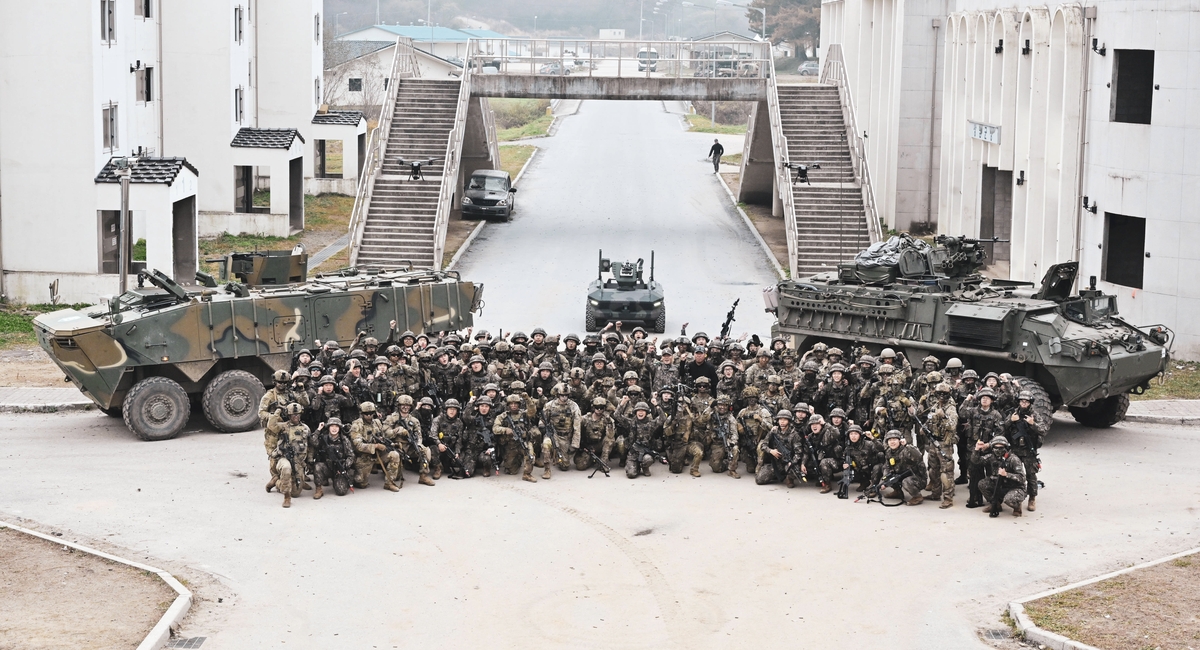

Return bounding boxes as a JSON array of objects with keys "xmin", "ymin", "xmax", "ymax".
[{"xmin": 457, "ymin": 101, "xmax": 776, "ymax": 336}]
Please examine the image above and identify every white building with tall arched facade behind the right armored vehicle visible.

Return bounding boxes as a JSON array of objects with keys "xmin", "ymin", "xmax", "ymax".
[{"xmin": 822, "ymin": 0, "xmax": 1200, "ymax": 359}]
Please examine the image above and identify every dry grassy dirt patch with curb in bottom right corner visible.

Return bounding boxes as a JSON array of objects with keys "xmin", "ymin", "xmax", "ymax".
[{"xmin": 1025, "ymin": 554, "xmax": 1200, "ymax": 650}]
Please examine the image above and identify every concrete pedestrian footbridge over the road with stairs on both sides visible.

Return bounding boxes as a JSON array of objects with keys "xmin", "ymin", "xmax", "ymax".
[{"xmin": 350, "ymin": 38, "xmax": 881, "ymax": 277}]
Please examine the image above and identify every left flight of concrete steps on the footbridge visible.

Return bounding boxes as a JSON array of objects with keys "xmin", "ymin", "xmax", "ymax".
[{"xmin": 358, "ymin": 79, "xmax": 460, "ymax": 269}]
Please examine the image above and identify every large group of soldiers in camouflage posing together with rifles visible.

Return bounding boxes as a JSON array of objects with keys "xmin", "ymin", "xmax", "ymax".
[{"xmin": 259, "ymin": 323, "xmax": 1050, "ymax": 517}]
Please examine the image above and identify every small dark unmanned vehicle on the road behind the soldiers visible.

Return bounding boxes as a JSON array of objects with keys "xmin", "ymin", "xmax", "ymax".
[{"xmin": 583, "ymin": 251, "xmax": 667, "ymax": 332}]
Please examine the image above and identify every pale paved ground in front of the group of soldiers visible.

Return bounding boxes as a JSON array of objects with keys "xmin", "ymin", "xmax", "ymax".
[{"xmin": 0, "ymin": 411, "xmax": 1200, "ymax": 649}]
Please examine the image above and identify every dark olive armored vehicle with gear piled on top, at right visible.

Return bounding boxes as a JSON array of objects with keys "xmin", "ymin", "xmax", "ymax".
[{"xmin": 764, "ymin": 235, "xmax": 1174, "ymax": 427}]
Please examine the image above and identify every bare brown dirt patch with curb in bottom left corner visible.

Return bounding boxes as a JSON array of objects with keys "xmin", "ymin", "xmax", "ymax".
[{"xmin": 0, "ymin": 529, "xmax": 175, "ymax": 650}]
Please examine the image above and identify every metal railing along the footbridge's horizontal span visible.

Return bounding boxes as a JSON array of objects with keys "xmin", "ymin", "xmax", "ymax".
[{"xmin": 464, "ymin": 38, "xmax": 774, "ymax": 78}]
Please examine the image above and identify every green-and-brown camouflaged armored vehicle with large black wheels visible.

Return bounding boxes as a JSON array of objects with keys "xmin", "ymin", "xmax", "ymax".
[{"xmin": 34, "ymin": 265, "xmax": 484, "ymax": 440}]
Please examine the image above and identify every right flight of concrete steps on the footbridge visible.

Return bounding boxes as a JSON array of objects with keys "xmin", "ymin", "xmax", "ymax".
[{"xmin": 779, "ymin": 84, "xmax": 871, "ymax": 277}]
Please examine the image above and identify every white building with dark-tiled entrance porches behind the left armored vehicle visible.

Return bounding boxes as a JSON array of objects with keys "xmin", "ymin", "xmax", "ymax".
[{"xmin": 0, "ymin": 0, "xmax": 324, "ymax": 302}]
